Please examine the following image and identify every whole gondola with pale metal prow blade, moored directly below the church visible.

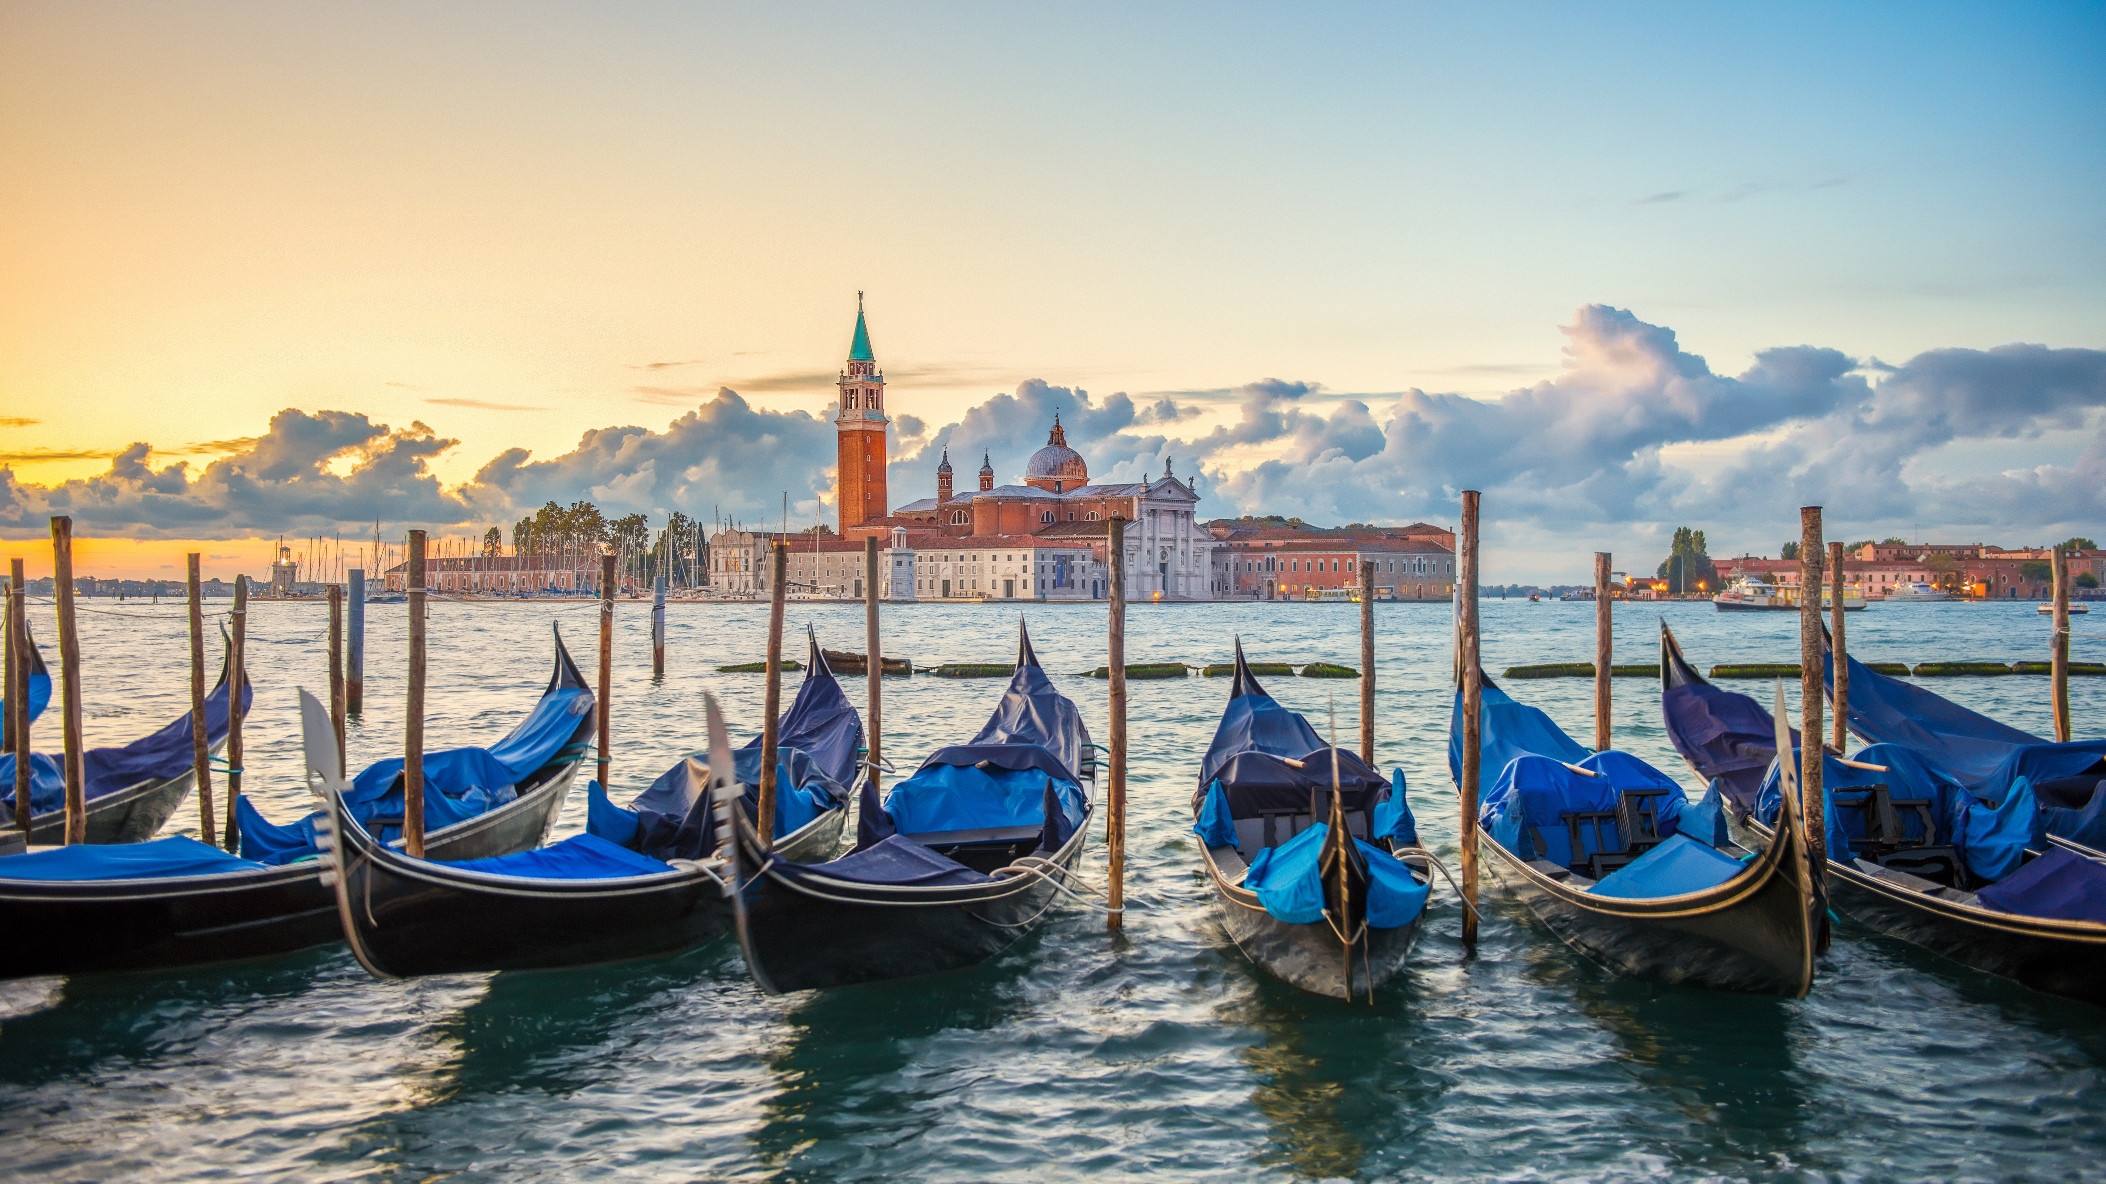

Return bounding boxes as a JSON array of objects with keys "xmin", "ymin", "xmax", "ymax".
[{"xmin": 731, "ymin": 624, "xmax": 1093, "ymax": 994}]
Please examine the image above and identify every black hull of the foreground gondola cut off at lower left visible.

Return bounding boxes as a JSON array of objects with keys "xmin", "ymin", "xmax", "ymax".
[{"xmin": 0, "ymin": 761, "xmax": 577, "ymax": 978}]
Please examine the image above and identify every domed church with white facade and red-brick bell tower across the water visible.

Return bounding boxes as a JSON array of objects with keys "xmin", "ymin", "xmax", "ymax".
[{"xmin": 821, "ymin": 295, "xmax": 1221, "ymax": 600}]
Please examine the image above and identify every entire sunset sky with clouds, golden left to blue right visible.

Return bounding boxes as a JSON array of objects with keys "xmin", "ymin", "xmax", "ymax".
[{"xmin": 0, "ymin": 0, "xmax": 2106, "ymax": 581}]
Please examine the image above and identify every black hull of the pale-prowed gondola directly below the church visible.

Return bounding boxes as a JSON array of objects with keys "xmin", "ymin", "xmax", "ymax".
[{"xmin": 735, "ymin": 811, "xmax": 1095, "ymax": 994}]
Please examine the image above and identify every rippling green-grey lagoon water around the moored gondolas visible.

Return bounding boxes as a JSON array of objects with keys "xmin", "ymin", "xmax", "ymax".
[{"xmin": 0, "ymin": 600, "xmax": 2106, "ymax": 1182}]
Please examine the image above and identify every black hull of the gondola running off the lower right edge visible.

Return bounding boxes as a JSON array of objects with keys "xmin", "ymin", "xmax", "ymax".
[{"xmin": 1735, "ymin": 820, "xmax": 2106, "ymax": 1007}]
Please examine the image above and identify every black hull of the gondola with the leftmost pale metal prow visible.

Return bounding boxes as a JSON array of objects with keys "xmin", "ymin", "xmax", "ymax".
[{"xmin": 335, "ymin": 787, "xmax": 847, "ymax": 978}]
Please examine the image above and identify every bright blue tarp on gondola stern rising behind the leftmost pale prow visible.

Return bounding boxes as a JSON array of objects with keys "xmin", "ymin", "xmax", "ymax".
[{"xmin": 234, "ymin": 685, "xmax": 592, "ymax": 864}]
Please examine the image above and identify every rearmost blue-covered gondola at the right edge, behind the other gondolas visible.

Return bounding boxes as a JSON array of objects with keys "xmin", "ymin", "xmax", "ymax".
[{"xmin": 1822, "ymin": 643, "xmax": 2106, "ymax": 846}]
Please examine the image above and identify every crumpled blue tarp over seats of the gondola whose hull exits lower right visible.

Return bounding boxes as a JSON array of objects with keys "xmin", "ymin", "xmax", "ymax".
[{"xmin": 1754, "ymin": 744, "xmax": 2045, "ymax": 883}]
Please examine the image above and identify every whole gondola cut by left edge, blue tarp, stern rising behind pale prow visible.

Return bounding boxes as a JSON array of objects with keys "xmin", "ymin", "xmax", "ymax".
[{"xmin": 0, "ymin": 634, "xmax": 594, "ymax": 978}]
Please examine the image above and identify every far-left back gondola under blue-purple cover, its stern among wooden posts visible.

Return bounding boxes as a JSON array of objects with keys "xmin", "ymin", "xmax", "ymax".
[{"xmin": 0, "ymin": 619, "xmax": 255, "ymax": 845}]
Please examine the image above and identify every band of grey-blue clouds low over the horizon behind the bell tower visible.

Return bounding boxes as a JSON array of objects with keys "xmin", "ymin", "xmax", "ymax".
[{"xmin": 0, "ymin": 305, "xmax": 2106, "ymax": 579}]
